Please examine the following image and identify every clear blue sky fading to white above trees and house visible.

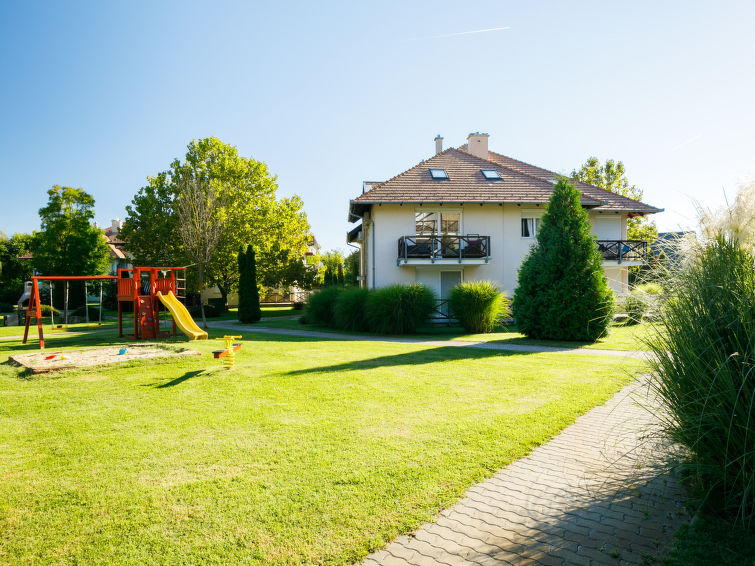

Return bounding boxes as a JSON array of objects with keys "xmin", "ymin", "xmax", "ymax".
[{"xmin": 0, "ymin": 0, "xmax": 755, "ymax": 249}]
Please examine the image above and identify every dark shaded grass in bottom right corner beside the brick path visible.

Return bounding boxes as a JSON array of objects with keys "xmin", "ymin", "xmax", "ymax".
[{"xmin": 664, "ymin": 519, "xmax": 755, "ymax": 566}]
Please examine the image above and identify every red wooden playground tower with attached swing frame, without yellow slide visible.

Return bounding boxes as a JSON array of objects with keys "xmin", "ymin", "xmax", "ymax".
[{"xmin": 23, "ymin": 267, "xmax": 190, "ymax": 349}]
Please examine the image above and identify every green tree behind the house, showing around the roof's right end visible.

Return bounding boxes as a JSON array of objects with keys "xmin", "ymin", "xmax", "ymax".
[{"xmin": 571, "ymin": 157, "xmax": 658, "ymax": 242}]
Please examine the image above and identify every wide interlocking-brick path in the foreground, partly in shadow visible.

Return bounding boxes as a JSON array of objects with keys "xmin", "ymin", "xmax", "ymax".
[{"xmin": 363, "ymin": 382, "xmax": 689, "ymax": 566}]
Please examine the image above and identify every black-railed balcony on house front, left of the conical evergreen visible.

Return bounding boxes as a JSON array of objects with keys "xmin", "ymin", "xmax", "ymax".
[{"xmin": 396, "ymin": 234, "xmax": 490, "ymax": 265}]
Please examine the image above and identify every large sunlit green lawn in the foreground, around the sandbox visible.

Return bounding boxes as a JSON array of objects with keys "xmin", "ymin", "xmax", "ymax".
[{"xmin": 0, "ymin": 331, "xmax": 642, "ymax": 564}]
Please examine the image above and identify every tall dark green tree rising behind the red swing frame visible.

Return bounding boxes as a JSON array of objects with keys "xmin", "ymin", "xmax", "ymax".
[{"xmin": 32, "ymin": 185, "xmax": 110, "ymax": 275}]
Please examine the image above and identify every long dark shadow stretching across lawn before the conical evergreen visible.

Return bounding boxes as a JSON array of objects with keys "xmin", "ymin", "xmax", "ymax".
[{"xmin": 286, "ymin": 346, "xmax": 530, "ymax": 375}]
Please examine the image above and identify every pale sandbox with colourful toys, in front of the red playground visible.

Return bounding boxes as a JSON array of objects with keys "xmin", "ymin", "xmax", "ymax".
[{"xmin": 8, "ymin": 343, "xmax": 199, "ymax": 373}]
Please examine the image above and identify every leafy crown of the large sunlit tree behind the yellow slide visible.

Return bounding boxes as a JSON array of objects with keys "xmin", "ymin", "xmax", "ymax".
[{"xmin": 122, "ymin": 137, "xmax": 311, "ymax": 296}]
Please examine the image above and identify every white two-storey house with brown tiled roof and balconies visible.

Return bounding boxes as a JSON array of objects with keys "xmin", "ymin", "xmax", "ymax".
[{"xmin": 347, "ymin": 133, "xmax": 662, "ymax": 298}]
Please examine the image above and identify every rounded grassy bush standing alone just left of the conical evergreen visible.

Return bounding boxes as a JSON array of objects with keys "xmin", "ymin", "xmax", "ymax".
[{"xmin": 448, "ymin": 281, "xmax": 508, "ymax": 333}]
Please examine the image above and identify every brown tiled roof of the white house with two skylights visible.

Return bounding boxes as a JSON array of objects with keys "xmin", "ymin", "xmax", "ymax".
[{"xmin": 349, "ymin": 146, "xmax": 660, "ymax": 222}]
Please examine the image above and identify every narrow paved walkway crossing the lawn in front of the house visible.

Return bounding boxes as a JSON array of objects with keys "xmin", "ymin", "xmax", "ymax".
[{"xmin": 207, "ymin": 321, "xmax": 647, "ymax": 359}]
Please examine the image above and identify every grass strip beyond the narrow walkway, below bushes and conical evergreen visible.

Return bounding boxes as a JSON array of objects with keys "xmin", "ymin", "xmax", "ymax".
[{"xmin": 236, "ymin": 319, "xmax": 656, "ymax": 350}]
